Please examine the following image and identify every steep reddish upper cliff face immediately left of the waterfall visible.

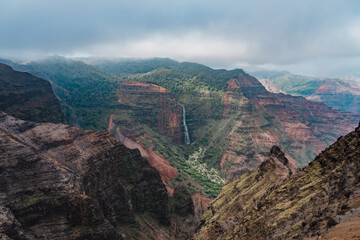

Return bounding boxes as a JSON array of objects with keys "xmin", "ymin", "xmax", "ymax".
[{"xmin": 113, "ymin": 81, "xmax": 181, "ymax": 144}]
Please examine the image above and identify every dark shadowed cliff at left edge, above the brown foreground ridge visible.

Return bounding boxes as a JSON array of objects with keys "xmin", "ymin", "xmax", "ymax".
[{"xmin": 0, "ymin": 63, "xmax": 65, "ymax": 123}]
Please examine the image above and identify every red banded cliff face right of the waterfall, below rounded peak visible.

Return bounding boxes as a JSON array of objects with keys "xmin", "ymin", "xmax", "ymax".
[{"xmin": 221, "ymin": 74, "xmax": 360, "ymax": 179}]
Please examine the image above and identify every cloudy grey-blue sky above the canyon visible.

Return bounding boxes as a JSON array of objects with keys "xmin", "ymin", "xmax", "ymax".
[{"xmin": 0, "ymin": 0, "xmax": 360, "ymax": 77}]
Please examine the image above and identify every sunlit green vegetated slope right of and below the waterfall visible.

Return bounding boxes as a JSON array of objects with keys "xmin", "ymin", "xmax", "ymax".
[{"xmin": 116, "ymin": 63, "xmax": 241, "ymax": 198}]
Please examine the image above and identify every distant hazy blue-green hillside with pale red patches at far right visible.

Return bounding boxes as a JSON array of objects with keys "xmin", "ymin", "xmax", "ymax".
[{"xmin": 253, "ymin": 71, "xmax": 360, "ymax": 113}]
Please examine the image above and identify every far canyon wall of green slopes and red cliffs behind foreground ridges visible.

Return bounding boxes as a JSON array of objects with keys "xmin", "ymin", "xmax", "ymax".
[{"xmin": 3, "ymin": 58, "xmax": 359, "ymax": 198}]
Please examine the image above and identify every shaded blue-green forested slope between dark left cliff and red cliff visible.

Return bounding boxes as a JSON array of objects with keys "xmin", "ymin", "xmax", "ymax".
[{"xmin": 28, "ymin": 57, "xmax": 119, "ymax": 130}]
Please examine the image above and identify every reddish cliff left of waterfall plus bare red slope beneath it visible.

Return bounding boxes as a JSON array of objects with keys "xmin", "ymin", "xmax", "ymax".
[{"xmin": 108, "ymin": 81, "xmax": 181, "ymax": 194}]
